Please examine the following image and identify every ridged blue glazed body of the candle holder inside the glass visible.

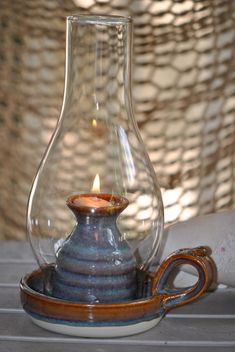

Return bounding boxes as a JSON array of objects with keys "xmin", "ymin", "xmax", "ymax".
[{"xmin": 52, "ymin": 192, "xmax": 137, "ymax": 303}]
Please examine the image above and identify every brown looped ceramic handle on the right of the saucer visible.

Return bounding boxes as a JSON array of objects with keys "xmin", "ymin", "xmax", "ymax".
[{"xmin": 151, "ymin": 247, "xmax": 214, "ymax": 311}]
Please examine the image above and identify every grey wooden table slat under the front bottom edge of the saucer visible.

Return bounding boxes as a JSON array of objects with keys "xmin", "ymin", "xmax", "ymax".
[{"xmin": 0, "ymin": 313, "xmax": 235, "ymax": 347}]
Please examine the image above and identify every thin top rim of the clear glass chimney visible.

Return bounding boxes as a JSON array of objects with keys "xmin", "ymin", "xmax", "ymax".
[{"xmin": 66, "ymin": 14, "xmax": 132, "ymax": 24}]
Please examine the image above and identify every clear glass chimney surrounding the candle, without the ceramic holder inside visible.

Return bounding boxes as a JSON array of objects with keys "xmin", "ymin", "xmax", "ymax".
[{"xmin": 27, "ymin": 15, "xmax": 163, "ymax": 278}]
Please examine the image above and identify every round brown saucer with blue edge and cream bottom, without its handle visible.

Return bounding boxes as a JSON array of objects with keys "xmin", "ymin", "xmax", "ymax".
[{"xmin": 20, "ymin": 267, "xmax": 163, "ymax": 338}]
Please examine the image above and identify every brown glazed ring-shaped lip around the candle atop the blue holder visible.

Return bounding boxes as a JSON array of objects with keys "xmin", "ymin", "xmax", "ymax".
[{"xmin": 66, "ymin": 193, "xmax": 129, "ymax": 216}]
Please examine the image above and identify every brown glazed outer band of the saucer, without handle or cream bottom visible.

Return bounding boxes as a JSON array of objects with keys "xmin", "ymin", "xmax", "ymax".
[{"xmin": 20, "ymin": 269, "xmax": 161, "ymax": 321}]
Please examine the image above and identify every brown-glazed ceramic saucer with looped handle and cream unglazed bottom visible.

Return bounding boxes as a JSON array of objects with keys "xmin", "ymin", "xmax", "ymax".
[{"xmin": 20, "ymin": 247, "xmax": 213, "ymax": 338}]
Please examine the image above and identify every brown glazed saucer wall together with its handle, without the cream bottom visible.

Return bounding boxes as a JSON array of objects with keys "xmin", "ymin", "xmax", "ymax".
[{"xmin": 20, "ymin": 246, "xmax": 215, "ymax": 322}]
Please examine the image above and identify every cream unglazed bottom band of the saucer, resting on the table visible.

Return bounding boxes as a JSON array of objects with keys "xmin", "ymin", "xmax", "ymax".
[{"xmin": 30, "ymin": 316, "xmax": 162, "ymax": 338}]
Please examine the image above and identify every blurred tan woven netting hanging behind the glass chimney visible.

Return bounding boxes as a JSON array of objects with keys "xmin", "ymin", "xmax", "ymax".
[{"xmin": 0, "ymin": 0, "xmax": 235, "ymax": 239}]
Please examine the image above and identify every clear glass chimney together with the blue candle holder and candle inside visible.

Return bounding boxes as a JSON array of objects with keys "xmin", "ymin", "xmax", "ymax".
[{"xmin": 27, "ymin": 15, "xmax": 163, "ymax": 302}]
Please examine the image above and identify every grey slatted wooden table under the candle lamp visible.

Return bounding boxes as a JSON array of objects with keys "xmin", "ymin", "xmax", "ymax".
[{"xmin": 0, "ymin": 241, "xmax": 235, "ymax": 352}]
